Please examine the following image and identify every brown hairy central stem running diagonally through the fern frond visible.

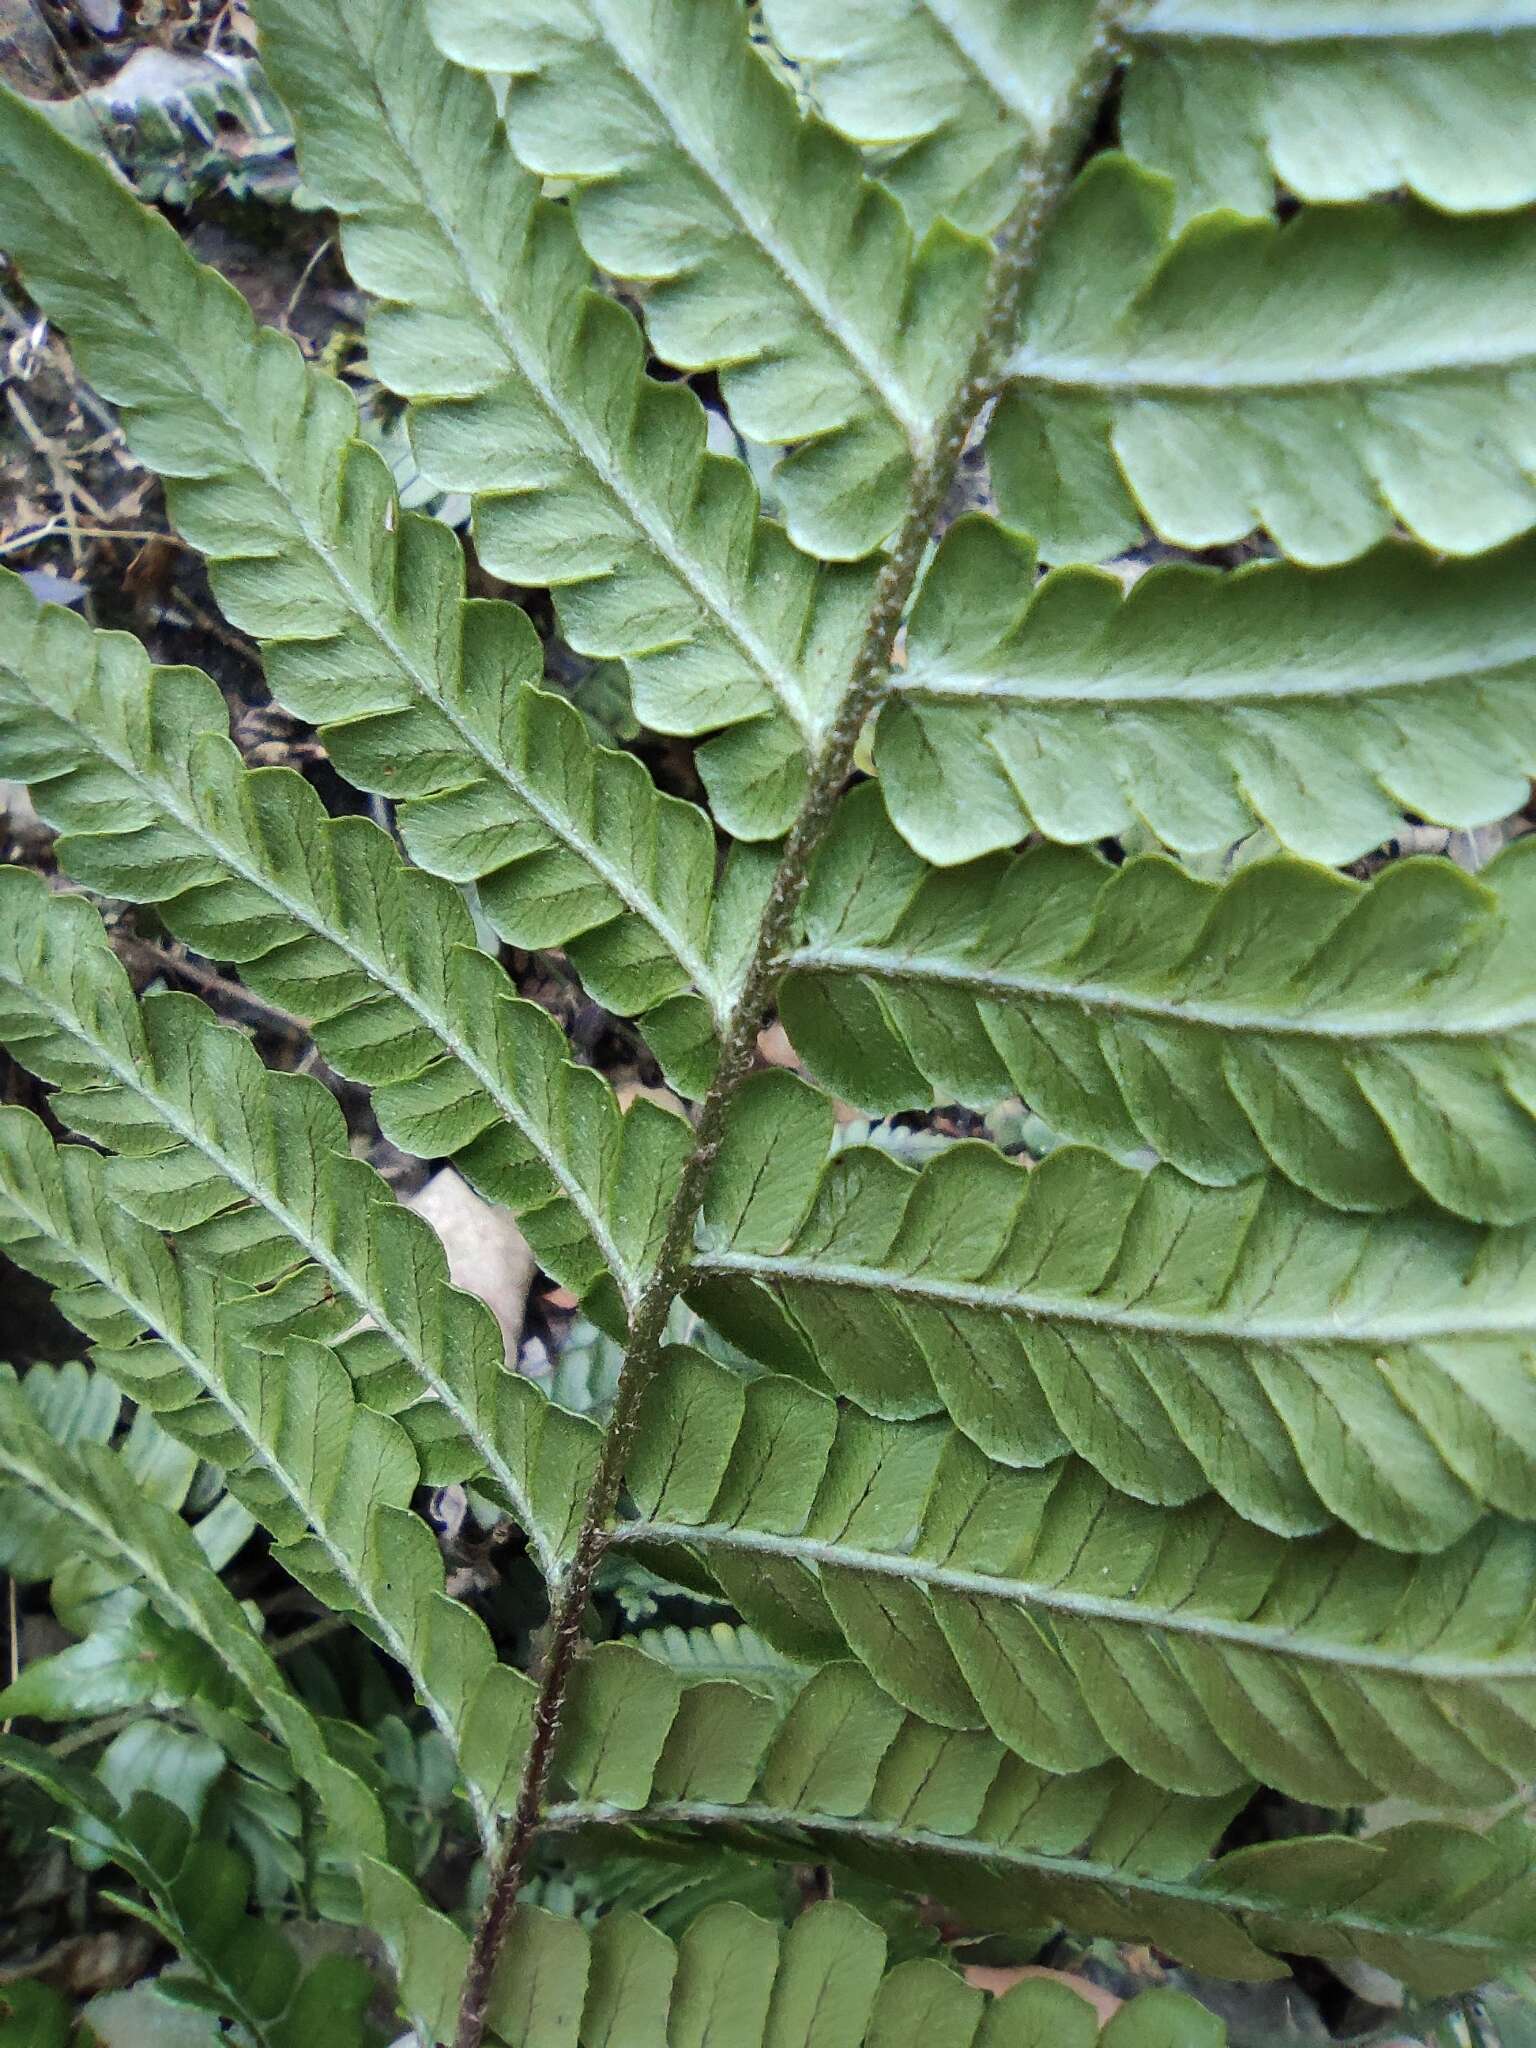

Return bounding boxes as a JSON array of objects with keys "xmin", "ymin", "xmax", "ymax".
[{"xmin": 455, "ymin": 12, "xmax": 1126, "ymax": 2048}]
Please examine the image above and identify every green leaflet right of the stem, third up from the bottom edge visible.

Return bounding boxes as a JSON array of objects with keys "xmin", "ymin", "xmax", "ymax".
[{"xmin": 612, "ymin": 1354, "xmax": 1536, "ymax": 1806}]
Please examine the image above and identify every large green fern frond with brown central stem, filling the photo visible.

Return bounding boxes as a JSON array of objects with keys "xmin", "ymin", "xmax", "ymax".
[{"xmin": 0, "ymin": 0, "xmax": 1536, "ymax": 2048}]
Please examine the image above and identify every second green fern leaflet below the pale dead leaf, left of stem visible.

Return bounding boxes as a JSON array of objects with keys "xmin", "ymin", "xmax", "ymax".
[{"xmin": 0, "ymin": 1110, "xmax": 537, "ymax": 1835}]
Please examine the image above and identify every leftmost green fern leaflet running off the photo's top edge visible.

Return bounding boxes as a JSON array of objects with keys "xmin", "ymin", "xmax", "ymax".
[{"xmin": 258, "ymin": 0, "xmax": 872, "ymax": 840}]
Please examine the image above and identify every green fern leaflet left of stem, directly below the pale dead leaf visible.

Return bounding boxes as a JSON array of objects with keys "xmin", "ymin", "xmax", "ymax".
[{"xmin": 0, "ymin": 868, "xmax": 614, "ymax": 1569}]
